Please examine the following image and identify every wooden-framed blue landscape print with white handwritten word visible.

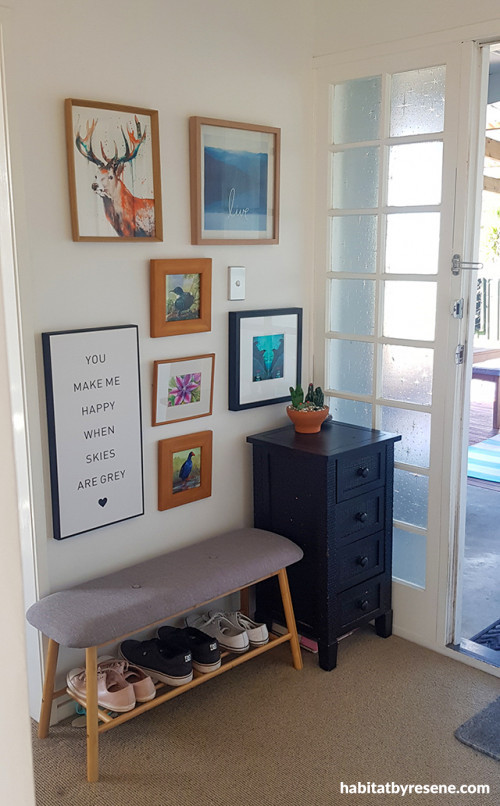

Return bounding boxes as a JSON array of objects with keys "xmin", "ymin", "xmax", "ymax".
[{"xmin": 189, "ymin": 117, "xmax": 281, "ymax": 245}]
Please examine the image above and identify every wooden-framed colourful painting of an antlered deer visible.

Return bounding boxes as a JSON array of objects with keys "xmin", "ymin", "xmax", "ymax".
[{"xmin": 65, "ymin": 98, "xmax": 163, "ymax": 241}]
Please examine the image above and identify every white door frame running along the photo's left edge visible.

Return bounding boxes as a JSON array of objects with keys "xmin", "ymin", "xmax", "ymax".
[{"xmin": 0, "ymin": 20, "xmax": 37, "ymax": 806}]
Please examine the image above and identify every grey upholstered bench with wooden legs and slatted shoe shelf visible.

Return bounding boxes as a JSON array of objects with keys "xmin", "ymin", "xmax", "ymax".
[{"xmin": 27, "ymin": 528, "xmax": 302, "ymax": 781}]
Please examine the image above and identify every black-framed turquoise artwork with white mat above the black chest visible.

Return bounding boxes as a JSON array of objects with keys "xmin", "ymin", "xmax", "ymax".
[{"xmin": 228, "ymin": 308, "xmax": 303, "ymax": 411}]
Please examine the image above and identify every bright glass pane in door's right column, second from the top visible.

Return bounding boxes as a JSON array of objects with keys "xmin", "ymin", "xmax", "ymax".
[{"xmin": 388, "ymin": 143, "xmax": 443, "ymax": 207}]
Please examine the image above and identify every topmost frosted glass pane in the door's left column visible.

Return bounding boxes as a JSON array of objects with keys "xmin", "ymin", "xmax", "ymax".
[{"xmin": 333, "ymin": 76, "xmax": 382, "ymax": 143}]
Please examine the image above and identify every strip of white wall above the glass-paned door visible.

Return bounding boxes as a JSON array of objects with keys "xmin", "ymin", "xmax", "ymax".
[{"xmin": 314, "ymin": 0, "xmax": 499, "ymax": 56}]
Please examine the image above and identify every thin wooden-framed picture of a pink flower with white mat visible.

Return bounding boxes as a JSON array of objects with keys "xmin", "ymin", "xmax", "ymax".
[{"xmin": 152, "ymin": 353, "xmax": 215, "ymax": 426}]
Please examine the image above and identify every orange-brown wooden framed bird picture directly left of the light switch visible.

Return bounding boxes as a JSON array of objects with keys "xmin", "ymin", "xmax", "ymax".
[{"xmin": 150, "ymin": 258, "xmax": 212, "ymax": 339}]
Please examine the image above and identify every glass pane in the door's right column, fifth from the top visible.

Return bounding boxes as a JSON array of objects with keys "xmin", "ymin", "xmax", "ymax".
[{"xmin": 382, "ymin": 344, "xmax": 434, "ymax": 406}]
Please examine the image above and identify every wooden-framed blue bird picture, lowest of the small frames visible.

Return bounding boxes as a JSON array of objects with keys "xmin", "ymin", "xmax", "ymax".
[{"xmin": 158, "ymin": 431, "xmax": 212, "ymax": 510}]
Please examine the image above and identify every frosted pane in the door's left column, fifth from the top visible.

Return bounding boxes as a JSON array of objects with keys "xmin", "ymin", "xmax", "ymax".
[{"xmin": 327, "ymin": 339, "xmax": 373, "ymax": 395}]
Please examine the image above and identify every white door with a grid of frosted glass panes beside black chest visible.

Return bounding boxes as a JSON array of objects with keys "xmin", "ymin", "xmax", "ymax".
[{"xmin": 314, "ymin": 43, "xmax": 486, "ymax": 647}]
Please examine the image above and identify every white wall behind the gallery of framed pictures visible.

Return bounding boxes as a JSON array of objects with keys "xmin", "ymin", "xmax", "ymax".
[{"xmin": 4, "ymin": 0, "xmax": 312, "ymax": 712}]
